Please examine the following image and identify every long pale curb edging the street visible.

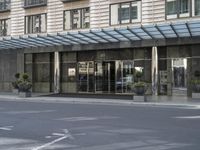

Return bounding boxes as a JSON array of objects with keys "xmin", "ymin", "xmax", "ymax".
[{"xmin": 0, "ymin": 96, "xmax": 200, "ymax": 109}]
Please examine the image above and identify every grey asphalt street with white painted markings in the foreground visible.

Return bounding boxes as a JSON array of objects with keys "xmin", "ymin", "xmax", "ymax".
[{"xmin": 0, "ymin": 100, "xmax": 200, "ymax": 150}]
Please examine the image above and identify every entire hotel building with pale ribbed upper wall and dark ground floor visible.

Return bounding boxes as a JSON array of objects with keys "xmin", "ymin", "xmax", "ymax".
[{"xmin": 0, "ymin": 0, "xmax": 200, "ymax": 97}]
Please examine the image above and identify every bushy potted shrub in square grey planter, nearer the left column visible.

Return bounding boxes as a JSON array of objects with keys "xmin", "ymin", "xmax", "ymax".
[{"xmin": 18, "ymin": 73, "xmax": 32, "ymax": 97}]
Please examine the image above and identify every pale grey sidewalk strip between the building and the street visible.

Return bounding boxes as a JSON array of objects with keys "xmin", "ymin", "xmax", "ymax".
[{"xmin": 0, "ymin": 92, "xmax": 200, "ymax": 109}]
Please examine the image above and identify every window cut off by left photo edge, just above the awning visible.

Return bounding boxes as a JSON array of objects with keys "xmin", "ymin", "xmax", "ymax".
[{"xmin": 0, "ymin": 19, "xmax": 10, "ymax": 36}]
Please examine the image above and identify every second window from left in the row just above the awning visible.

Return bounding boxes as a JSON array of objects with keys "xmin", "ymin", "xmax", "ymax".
[{"xmin": 25, "ymin": 14, "xmax": 47, "ymax": 34}]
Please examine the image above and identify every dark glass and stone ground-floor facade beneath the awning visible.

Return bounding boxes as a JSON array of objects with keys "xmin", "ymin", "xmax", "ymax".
[{"xmin": 0, "ymin": 39, "xmax": 200, "ymax": 97}]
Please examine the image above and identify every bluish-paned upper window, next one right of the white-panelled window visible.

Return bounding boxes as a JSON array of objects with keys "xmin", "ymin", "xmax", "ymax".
[{"xmin": 166, "ymin": 0, "xmax": 191, "ymax": 19}]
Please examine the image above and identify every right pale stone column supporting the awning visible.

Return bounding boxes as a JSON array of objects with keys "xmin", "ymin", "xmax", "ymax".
[{"xmin": 151, "ymin": 47, "xmax": 158, "ymax": 95}]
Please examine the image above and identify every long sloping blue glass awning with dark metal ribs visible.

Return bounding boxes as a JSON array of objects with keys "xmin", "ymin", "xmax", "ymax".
[{"xmin": 0, "ymin": 21, "xmax": 200, "ymax": 49}]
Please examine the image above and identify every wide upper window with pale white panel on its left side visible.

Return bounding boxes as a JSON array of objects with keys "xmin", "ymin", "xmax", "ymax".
[{"xmin": 110, "ymin": 1, "xmax": 141, "ymax": 25}]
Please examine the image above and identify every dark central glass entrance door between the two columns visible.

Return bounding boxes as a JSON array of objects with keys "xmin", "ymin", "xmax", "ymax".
[{"xmin": 95, "ymin": 61, "xmax": 115, "ymax": 93}]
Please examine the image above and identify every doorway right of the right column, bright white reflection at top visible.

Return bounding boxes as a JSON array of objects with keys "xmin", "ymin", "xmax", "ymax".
[{"xmin": 172, "ymin": 58, "xmax": 187, "ymax": 96}]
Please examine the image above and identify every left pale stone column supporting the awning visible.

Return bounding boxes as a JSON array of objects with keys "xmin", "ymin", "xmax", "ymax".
[{"xmin": 54, "ymin": 52, "xmax": 60, "ymax": 93}]
